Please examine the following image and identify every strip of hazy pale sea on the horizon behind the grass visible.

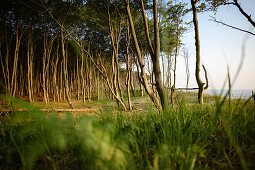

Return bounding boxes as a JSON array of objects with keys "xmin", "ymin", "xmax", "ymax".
[{"xmin": 204, "ymin": 89, "xmax": 255, "ymax": 99}]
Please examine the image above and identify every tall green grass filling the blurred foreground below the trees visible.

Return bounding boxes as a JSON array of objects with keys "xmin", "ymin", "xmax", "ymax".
[{"xmin": 0, "ymin": 93, "xmax": 255, "ymax": 170}]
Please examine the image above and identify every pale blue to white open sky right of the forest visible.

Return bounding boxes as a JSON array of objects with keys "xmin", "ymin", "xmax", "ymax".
[{"xmin": 160, "ymin": 0, "xmax": 255, "ymax": 90}]
